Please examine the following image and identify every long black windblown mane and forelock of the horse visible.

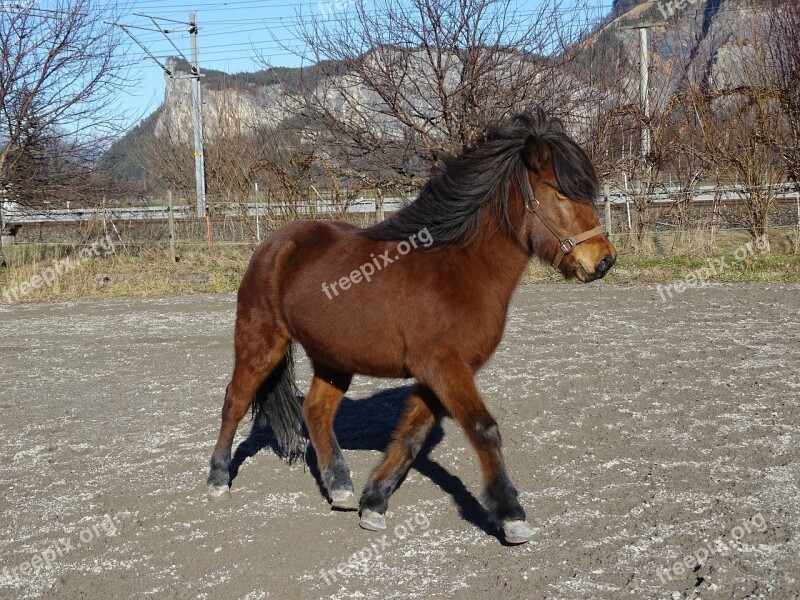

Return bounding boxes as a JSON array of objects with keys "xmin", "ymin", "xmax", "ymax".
[{"xmin": 361, "ymin": 108, "xmax": 599, "ymax": 246}]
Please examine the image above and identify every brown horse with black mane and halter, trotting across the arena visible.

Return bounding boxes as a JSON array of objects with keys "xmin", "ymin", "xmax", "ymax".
[{"xmin": 208, "ymin": 110, "xmax": 616, "ymax": 543}]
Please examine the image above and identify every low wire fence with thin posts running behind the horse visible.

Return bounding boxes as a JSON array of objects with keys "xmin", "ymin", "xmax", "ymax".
[{"xmin": 3, "ymin": 195, "xmax": 800, "ymax": 262}]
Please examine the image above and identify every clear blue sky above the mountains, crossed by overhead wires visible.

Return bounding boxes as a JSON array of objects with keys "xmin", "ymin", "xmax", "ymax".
[{"xmin": 114, "ymin": 0, "xmax": 612, "ymax": 123}]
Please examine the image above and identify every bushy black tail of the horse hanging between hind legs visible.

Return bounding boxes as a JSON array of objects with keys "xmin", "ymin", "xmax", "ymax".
[{"xmin": 251, "ymin": 345, "xmax": 306, "ymax": 462}]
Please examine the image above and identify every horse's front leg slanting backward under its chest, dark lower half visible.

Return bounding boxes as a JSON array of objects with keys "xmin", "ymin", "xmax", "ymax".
[{"xmin": 360, "ymin": 384, "xmax": 442, "ymax": 530}]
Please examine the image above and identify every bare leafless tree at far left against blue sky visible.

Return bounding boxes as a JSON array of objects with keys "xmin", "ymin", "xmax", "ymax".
[{"xmin": 0, "ymin": 0, "xmax": 128, "ymax": 260}]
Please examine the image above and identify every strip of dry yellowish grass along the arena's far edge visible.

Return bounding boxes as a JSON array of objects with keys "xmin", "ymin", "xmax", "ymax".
[{"xmin": 0, "ymin": 231, "xmax": 800, "ymax": 304}]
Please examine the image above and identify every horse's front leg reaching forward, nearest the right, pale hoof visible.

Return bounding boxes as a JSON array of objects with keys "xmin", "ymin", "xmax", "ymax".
[{"xmin": 420, "ymin": 352, "xmax": 534, "ymax": 544}]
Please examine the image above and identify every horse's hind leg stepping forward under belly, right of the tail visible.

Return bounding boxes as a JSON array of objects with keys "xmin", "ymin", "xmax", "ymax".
[{"xmin": 303, "ymin": 365, "xmax": 358, "ymax": 510}]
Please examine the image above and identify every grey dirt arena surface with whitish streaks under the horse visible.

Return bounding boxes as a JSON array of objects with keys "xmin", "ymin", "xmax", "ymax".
[{"xmin": 0, "ymin": 283, "xmax": 800, "ymax": 600}]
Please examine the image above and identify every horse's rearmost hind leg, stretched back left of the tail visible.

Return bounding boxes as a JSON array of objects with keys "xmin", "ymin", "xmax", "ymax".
[{"xmin": 208, "ymin": 330, "xmax": 291, "ymax": 500}]
